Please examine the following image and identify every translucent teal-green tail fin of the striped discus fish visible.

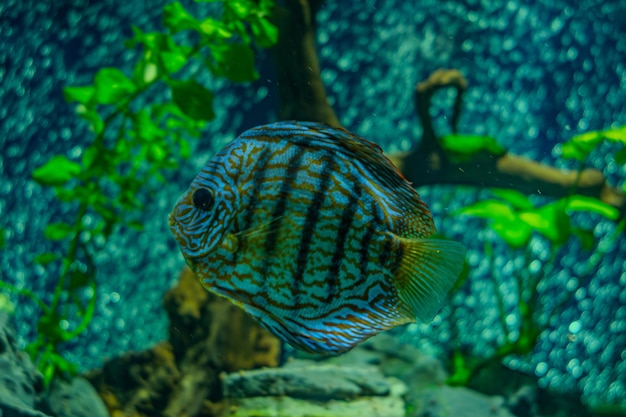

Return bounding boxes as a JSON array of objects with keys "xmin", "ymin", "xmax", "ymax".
[{"xmin": 394, "ymin": 238, "xmax": 465, "ymax": 322}]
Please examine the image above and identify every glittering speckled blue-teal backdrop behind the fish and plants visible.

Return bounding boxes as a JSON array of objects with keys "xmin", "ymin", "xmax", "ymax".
[{"xmin": 0, "ymin": 0, "xmax": 626, "ymax": 408}]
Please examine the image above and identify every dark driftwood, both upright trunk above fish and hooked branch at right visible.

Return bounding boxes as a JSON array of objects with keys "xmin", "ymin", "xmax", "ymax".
[{"xmin": 274, "ymin": 0, "xmax": 626, "ymax": 212}]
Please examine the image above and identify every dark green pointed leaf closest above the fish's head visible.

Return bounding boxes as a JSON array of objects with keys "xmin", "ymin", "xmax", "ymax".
[{"xmin": 169, "ymin": 80, "xmax": 215, "ymax": 120}]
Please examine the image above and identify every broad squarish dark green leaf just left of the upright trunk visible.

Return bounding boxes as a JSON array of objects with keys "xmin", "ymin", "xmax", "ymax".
[{"xmin": 211, "ymin": 43, "xmax": 259, "ymax": 82}]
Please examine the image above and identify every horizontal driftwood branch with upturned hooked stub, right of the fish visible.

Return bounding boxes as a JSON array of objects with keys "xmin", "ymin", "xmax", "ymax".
[{"xmin": 393, "ymin": 70, "xmax": 626, "ymax": 211}]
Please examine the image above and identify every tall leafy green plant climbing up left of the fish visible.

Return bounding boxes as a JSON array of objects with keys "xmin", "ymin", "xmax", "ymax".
[{"xmin": 0, "ymin": 0, "xmax": 278, "ymax": 385}]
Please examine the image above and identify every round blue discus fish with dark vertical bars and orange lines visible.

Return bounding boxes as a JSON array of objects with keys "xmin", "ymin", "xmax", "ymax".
[{"xmin": 168, "ymin": 122, "xmax": 465, "ymax": 354}]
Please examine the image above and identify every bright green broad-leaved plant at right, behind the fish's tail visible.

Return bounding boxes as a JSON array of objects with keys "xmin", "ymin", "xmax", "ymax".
[{"xmin": 448, "ymin": 126, "xmax": 626, "ymax": 385}]
